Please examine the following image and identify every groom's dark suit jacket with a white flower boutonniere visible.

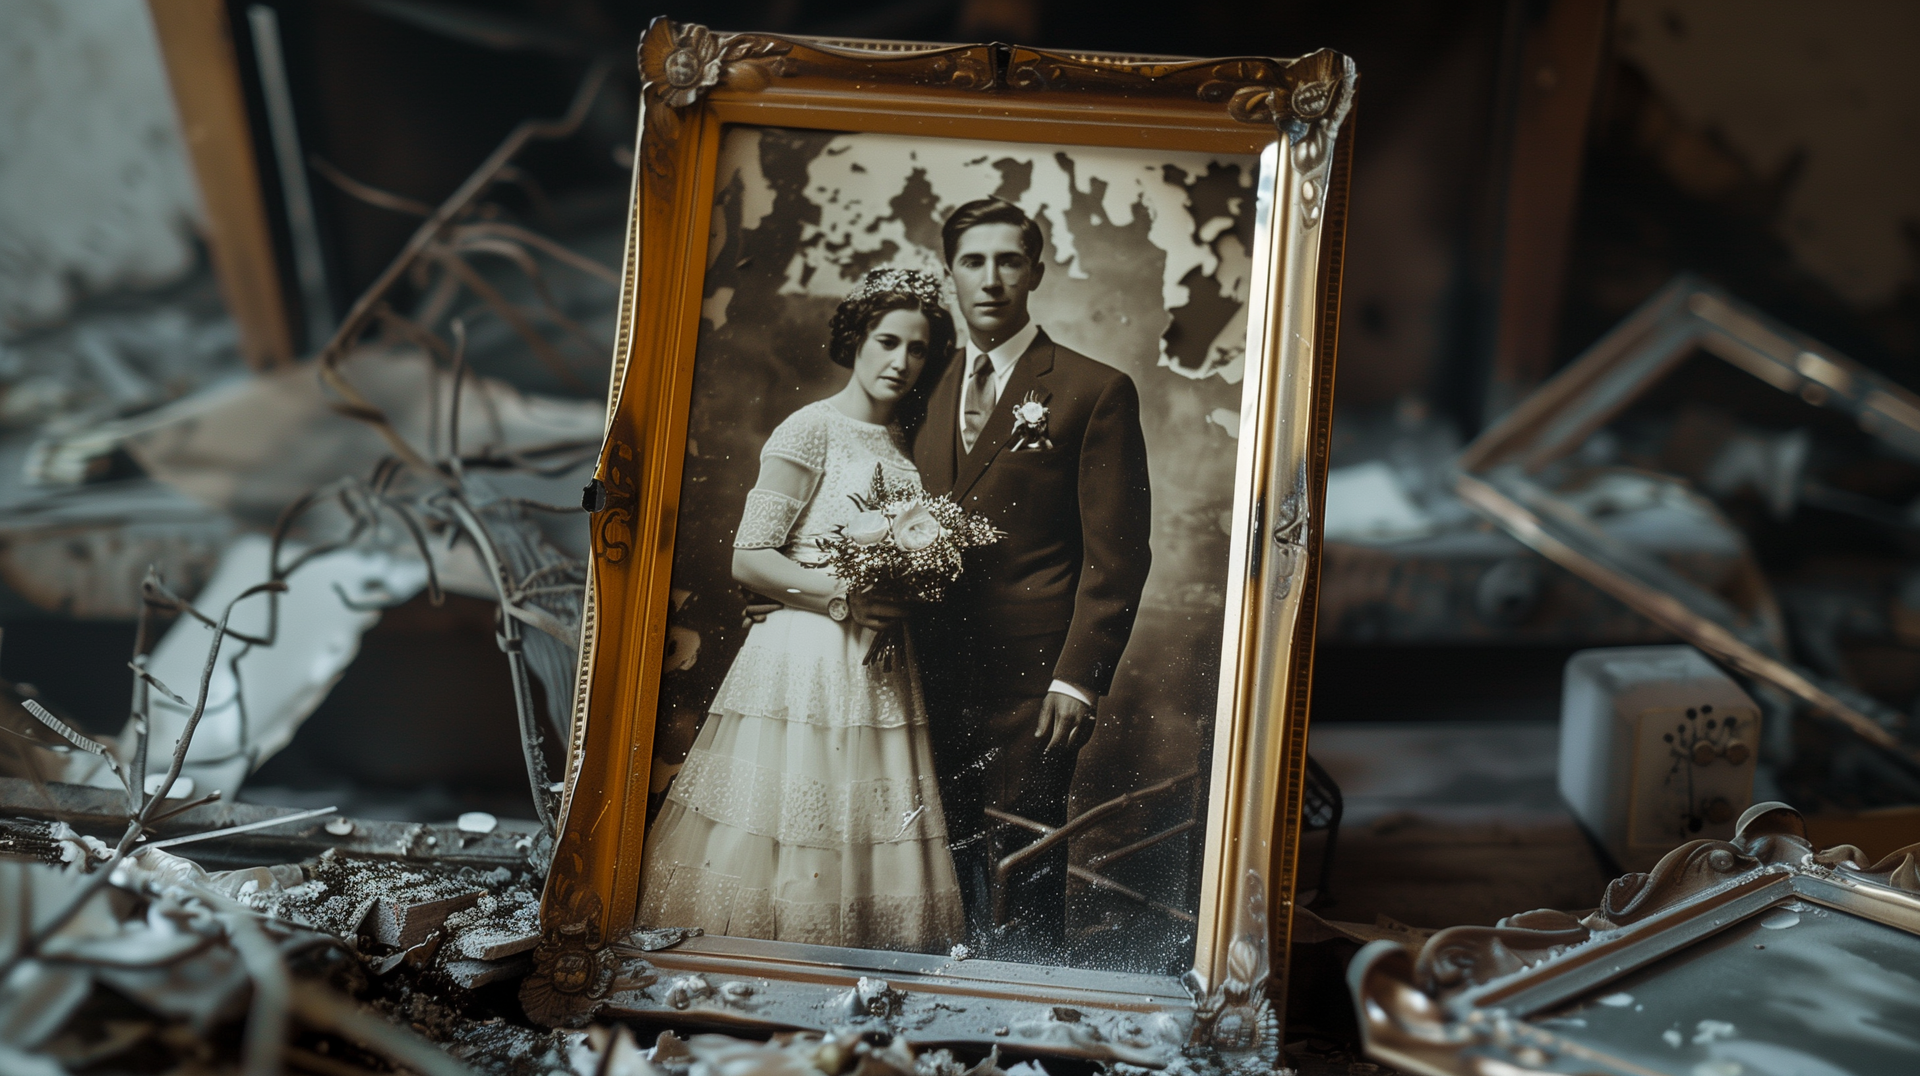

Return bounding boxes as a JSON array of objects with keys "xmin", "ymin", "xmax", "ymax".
[{"xmin": 914, "ymin": 332, "xmax": 1152, "ymax": 694}]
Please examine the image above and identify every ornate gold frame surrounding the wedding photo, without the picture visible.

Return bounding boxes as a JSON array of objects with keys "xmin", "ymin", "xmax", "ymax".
[{"xmin": 520, "ymin": 17, "xmax": 1356, "ymax": 1076}]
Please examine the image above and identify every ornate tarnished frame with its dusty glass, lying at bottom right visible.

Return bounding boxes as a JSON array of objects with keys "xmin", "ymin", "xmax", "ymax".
[{"xmin": 1348, "ymin": 803, "xmax": 1920, "ymax": 1076}]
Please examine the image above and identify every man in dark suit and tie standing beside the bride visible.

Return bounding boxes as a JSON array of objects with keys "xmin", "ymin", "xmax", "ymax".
[{"xmin": 914, "ymin": 198, "xmax": 1152, "ymax": 959}]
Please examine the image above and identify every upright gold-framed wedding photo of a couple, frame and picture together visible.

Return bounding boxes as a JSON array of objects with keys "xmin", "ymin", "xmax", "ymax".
[{"xmin": 522, "ymin": 19, "xmax": 1356, "ymax": 1066}]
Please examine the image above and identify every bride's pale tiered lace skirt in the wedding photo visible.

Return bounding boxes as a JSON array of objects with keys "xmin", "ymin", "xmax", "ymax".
[{"xmin": 639, "ymin": 609, "xmax": 964, "ymax": 951}]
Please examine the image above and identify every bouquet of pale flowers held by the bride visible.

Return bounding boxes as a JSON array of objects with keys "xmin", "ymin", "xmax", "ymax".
[{"xmin": 820, "ymin": 465, "xmax": 1000, "ymax": 669}]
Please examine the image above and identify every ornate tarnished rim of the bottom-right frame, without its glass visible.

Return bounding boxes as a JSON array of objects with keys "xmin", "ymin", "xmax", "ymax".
[{"xmin": 1348, "ymin": 803, "xmax": 1920, "ymax": 1076}]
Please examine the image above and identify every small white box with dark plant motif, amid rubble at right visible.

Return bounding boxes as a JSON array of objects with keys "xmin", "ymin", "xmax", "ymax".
[{"xmin": 1559, "ymin": 646, "xmax": 1761, "ymax": 870}]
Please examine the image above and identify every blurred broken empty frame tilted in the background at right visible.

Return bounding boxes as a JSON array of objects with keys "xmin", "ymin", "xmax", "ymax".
[{"xmin": 1455, "ymin": 275, "xmax": 1920, "ymax": 765}]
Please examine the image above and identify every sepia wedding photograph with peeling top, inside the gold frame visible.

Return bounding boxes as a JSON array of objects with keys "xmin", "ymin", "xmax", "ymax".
[{"xmin": 637, "ymin": 127, "xmax": 1258, "ymax": 974}]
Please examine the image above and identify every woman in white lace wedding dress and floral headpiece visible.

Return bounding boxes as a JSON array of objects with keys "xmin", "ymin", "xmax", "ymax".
[{"xmin": 639, "ymin": 269, "xmax": 964, "ymax": 951}]
